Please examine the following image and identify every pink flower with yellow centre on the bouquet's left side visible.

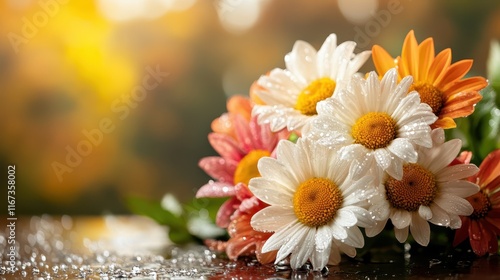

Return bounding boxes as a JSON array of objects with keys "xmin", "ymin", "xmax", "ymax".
[{"xmin": 196, "ymin": 97, "xmax": 286, "ymax": 228}]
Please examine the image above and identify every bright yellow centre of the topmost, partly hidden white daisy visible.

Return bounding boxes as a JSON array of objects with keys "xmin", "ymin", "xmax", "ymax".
[{"xmin": 295, "ymin": 78, "xmax": 336, "ymax": 116}]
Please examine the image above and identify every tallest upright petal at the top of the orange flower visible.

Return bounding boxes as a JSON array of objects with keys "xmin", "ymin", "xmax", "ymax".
[{"xmin": 398, "ymin": 30, "xmax": 419, "ymax": 81}]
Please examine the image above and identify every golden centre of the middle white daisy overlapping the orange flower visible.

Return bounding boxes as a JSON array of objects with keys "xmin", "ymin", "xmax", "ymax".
[{"xmin": 351, "ymin": 112, "xmax": 397, "ymax": 149}]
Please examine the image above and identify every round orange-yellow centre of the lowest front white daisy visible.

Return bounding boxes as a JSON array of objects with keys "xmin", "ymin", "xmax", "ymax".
[{"xmin": 293, "ymin": 178, "xmax": 343, "ymax": 227}]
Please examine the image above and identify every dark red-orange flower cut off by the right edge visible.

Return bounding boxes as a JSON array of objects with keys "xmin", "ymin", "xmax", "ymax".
[{"xmin": 453, "ymin": 150, "xmax": 500, "ymax": 256}]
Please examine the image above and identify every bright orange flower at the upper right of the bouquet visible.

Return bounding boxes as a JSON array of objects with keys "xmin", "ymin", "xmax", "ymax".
[{"xmin": 372, "ymin": 30, "xmax": 488, "ymax": 129}]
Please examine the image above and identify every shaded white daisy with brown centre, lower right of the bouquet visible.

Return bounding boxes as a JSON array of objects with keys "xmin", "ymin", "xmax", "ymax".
[{"xmin": 366, "ymin": 128, "xmax": 479, "ymax": 246}]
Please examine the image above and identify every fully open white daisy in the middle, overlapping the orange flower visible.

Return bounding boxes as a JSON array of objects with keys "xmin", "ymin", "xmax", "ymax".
[{"xmin": 304, "ymin": 69, "xmax": 437, "ymax": 180}]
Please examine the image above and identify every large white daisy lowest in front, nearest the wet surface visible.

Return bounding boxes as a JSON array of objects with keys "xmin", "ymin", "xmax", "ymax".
[{"xmin": 249, "ymin": 138, "xmax": 375, "ymax": 270}]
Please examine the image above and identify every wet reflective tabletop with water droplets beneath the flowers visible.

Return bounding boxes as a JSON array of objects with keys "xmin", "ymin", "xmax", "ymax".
[{"xmin": 0, "ymin": 216, "xmax": 500, "ymax": 279}]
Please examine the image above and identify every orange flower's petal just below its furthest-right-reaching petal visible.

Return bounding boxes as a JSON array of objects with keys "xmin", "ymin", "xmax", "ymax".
[{"xmin": 439, "ymin": 91, "xmax": 483, "ymax": 118}]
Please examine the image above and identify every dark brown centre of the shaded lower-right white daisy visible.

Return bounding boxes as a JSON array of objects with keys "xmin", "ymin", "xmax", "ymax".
[{"xmin": 385, "ymin": 163, "xmax": 437, "ymax": 212}]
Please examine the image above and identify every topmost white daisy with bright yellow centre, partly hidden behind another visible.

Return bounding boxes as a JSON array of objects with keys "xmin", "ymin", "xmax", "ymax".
[{"xmin": 252, "ymin": 34, "xmax": 371, "ymax": 131}]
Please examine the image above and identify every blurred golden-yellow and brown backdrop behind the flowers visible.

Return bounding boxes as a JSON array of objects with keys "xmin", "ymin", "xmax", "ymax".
[{"xmin": 0, "ymin": 0, "xmax": 500, "ymax": 214}]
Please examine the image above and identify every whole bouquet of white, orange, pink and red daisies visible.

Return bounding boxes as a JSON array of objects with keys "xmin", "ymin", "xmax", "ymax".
[{"xmin": 197, "ymin": 31, "xmax": 500, "ymax": 270}]
